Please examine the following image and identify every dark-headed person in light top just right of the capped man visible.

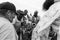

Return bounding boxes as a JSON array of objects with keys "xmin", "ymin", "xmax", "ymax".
[{"xmin": 13, "ymin": 10, "xmax": 23, "ymax": 40}]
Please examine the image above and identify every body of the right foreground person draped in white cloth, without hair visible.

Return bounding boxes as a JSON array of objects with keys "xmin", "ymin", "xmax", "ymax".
[{"xmin": 32, "ymin": 0, "xmax": 60, "ymax": 40}]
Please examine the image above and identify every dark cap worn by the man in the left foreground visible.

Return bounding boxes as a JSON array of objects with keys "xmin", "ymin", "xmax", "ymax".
[{"xmin": 0, "ymin": 2, "xmax": 16, "ymax": 13}]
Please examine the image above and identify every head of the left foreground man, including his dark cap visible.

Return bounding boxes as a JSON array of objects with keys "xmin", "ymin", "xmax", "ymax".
[{"xmin": 0, "ymin": 2, "xmax": 16, "ymax": 22}]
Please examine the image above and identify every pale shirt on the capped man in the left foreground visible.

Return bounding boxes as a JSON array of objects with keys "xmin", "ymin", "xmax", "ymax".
[{"xmin": 0, "ymin": 17, "xmax": 17, "ymax": 40}]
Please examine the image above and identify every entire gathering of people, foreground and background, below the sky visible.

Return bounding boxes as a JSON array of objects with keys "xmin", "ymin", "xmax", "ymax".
[{"xmin": 0, "ymin": 0, "xmax": 60, "ymax": 40}]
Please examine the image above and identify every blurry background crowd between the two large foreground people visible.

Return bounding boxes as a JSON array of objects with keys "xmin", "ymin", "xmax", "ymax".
[{"xmin": 14, "ymin": 10, "xmax": 40, "ymax": 40}]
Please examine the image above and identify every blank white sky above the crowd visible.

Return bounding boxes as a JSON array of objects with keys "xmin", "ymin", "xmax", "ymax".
[{"xmin": 0, "ymin": 0, "xmax": 45, "ymax": 16}]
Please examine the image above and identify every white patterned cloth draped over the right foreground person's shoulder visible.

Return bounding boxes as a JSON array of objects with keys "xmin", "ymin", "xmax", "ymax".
[{"xmin": 32, "ymin": 2, "xmax": 60, "ymax": 40}]
